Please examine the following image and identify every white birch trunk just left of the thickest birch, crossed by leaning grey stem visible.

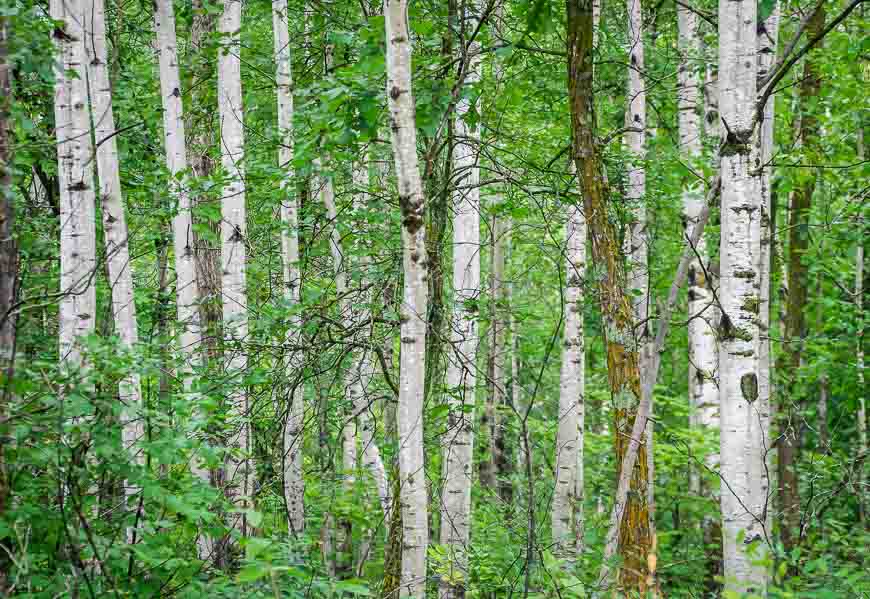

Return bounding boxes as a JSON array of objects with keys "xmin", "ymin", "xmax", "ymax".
[{"xmin": 677, "ymin": 0, "xmax": 719, "ymax": 495}]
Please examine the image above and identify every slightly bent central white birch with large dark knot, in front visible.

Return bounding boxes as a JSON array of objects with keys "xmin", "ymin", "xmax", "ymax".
[{"xmin": 384, "ymin": 0, "xmax": 429, "ymax": 598}]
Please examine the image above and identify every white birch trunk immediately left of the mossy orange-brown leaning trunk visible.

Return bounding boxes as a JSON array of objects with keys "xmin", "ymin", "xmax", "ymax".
[{"xmin": 551, "ymin": 195, "xmax": 586, "ymax": 562}]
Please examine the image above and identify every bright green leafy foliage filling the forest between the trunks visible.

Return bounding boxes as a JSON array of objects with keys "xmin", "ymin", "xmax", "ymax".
[{"xmin": 0, "ymin": 0, "xmax": 870, "ymax": 599}]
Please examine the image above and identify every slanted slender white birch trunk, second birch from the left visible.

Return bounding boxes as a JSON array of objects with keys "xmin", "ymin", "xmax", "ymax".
[{"xmin": 85, "ymin": 0, "xmax": 145, "ymax": 528}]
